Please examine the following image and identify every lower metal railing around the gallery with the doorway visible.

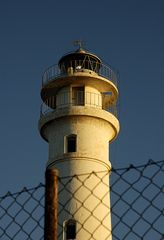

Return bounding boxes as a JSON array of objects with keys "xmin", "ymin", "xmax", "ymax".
[{"xmin": 40, "ymin": 91, "xmax": 117, "ymax": 117}]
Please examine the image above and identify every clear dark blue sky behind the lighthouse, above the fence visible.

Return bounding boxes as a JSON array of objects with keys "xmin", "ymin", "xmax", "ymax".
[{"xmin": 0, "ymin": 0, "xmax": 164, "ymax": 195}]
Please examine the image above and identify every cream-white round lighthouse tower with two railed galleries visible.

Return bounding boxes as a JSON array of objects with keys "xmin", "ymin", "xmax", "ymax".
[{"xmin": 39, "ymin": 43, "xmax": 119, "ymax": 240}]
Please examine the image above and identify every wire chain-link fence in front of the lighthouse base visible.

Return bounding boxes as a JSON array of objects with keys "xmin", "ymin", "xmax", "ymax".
[{"xmin": 0, "ymin": 160, "xmax": 164, "ymax": 240}]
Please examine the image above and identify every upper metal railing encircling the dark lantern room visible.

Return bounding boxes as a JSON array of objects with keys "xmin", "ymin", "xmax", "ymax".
[{"xmin": 42, "ymin": 60, "xmax": 117, "ymax": 86}]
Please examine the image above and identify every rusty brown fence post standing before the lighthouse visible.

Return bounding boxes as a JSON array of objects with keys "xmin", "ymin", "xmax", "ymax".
[{"xmin": 44, "ymin": 169, "xmax": 58, "ymax": 240}]
